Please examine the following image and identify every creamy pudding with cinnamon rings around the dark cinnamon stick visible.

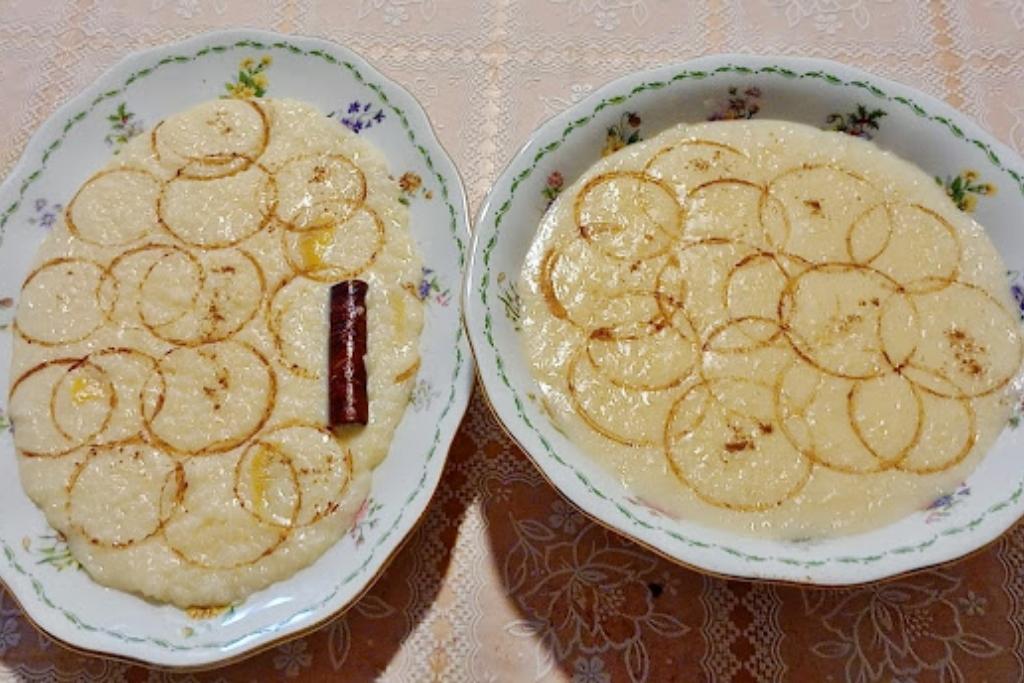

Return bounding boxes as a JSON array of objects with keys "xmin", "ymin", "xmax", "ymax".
[{"xmin": 9, "ymin": 99, "xmax": 423, "ymax": 606}]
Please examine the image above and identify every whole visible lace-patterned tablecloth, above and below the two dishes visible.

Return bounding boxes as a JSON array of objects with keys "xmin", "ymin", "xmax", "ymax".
[{"xmin": 0, "ymin": 0, "xmax": 1024, "ymax": 683}]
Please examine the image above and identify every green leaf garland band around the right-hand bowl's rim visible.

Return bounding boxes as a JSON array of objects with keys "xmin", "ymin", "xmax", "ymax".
[{"xmin": 477, "ymin": 65, "xmax": 1024, "ymax": 568}]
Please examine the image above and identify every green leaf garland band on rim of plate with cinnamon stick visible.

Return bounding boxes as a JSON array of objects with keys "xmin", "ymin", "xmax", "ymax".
[{"xmin": 0, "ymin": 39, "xmax": 466, "ymax": 651}]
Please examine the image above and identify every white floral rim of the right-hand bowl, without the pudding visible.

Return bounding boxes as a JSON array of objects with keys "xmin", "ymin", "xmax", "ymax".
[{"xmin": 464, "ymin": 55, "xmax": 1024, "ymax": 585}]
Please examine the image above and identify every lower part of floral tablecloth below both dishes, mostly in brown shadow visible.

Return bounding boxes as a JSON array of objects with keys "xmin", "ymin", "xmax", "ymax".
[{"xmin": 0, "ymin": 394, "xmax": 1024, "ymax": 683}]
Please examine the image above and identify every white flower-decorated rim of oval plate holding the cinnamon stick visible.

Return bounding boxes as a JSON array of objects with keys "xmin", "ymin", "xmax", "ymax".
[{"xmin": 0, "ymin": 31, "xmax": 473, "ymax": 668}]
